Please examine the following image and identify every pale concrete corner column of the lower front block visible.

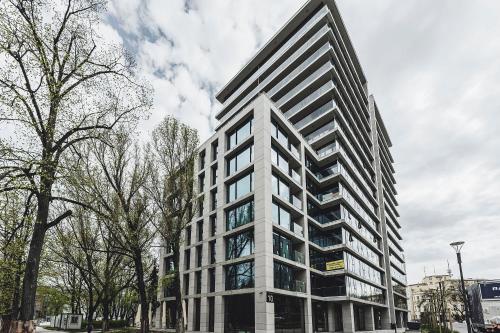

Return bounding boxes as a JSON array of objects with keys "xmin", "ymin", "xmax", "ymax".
[{"xmin": 254, "ymin": 95, "xmax": 274, "ymax": 333}]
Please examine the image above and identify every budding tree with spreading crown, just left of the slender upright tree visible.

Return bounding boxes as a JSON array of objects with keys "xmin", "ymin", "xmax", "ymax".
[{"xmin": 67, "ymin": 129, "xmax": 154, "ymax": 332}]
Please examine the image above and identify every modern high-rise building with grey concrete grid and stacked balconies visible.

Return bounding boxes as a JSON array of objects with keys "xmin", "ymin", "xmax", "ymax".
[{"xmin": 155, "ymin": 0, "xmax": 407, "ymax": 333}]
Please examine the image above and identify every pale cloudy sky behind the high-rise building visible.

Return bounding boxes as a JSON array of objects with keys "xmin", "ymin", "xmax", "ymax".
[{"xmin": 101, "ymin": 0, "xmax": 500, "ymax": 283}]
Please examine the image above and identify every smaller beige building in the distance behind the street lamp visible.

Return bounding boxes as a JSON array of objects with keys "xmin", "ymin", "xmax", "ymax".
[{"xmin": 407, "ymin": 273, "xmax": 482, "ymax": 321}]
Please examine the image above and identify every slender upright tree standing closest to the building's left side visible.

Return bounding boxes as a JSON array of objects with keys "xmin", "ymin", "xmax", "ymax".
[{"xmin": 148, "ymin": 117, "xmax": 199, "ymax": 332}]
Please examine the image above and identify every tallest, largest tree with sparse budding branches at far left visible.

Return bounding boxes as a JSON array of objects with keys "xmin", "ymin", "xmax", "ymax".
[{"xmin": 0, "ymin": 0, "xmax": 151, "ymax": 331}]
